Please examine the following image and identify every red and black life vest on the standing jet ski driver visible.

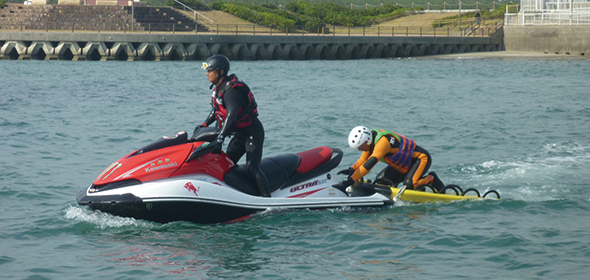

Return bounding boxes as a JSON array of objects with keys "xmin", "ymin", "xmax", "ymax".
[{"xmin": 211, "ymin": 74, "xmax": 258, "ymax": 128}]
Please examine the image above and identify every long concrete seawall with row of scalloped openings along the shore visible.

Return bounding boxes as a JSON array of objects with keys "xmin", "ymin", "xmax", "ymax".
[{"xmin": 0, "ymin": 29, "xmax": 503, "ymax": 61}]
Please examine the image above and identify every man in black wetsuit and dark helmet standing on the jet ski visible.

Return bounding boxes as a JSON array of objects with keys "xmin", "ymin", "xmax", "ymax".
[{"xmin": 194, "ymin": 54, "xmax": 270, "ymax": 197}]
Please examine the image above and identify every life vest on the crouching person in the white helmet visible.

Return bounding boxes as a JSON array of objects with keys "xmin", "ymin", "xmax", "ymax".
[{"xmin": 371, "ymin": 129, "xmax": 416, "ymax": 172}]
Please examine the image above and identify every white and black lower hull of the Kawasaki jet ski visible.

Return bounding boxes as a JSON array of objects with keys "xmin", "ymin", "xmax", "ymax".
[{"xmin": 77, "ymin": 174, "xmax": 392, "ymax": 224}]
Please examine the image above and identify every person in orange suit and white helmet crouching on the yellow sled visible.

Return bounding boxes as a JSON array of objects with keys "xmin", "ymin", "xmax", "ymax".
[{"xmin": 336, "ymin": 126, "xmax": 444, "ymax": 190}]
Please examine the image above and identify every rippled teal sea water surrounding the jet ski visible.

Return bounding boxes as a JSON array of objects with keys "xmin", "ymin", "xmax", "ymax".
[{"xmin": 0, "ymin": 58, "xmax": 590, "ymax": 279}]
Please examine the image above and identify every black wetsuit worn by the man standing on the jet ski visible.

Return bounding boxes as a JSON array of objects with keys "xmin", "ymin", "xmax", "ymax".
[{"xmin": 204, "ymin": 74, "xmax": 270, "ymax": 197}]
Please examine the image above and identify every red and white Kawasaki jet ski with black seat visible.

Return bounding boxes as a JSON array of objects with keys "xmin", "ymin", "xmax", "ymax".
[{"xmin": 76, "ymin": 128, "xmax": 393, "ymax": 223}]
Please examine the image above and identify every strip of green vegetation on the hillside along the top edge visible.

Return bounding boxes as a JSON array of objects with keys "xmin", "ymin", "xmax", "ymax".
[{"xmin": 0, "ymin": 0, "xmax": 504, "ymax": 29}]
